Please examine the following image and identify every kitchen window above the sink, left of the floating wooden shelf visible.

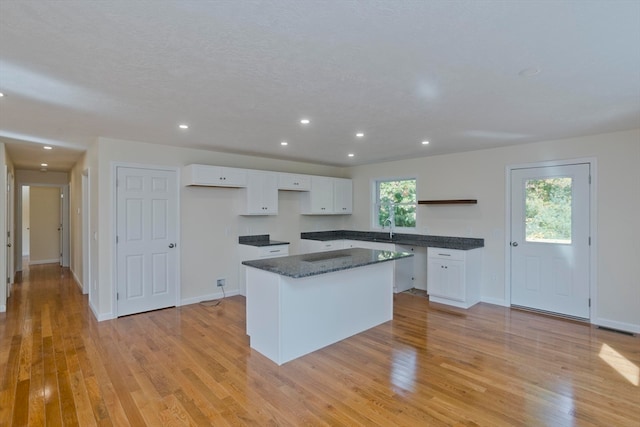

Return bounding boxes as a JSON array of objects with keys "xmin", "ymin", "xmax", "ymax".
[{"xmin": 373, "ymin": 178, "xmax": 418, "ymax": 228}]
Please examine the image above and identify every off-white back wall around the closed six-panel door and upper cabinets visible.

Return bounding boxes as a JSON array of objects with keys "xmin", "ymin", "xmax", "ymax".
[{"xmin": 80, "ymin": 138, "xmax": 344, "ymax": 319}]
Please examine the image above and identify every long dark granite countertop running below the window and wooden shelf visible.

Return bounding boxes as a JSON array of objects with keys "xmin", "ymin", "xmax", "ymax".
[{"xmin": 300, "ymin": 230, "xmax": 484, "ymax": 251}]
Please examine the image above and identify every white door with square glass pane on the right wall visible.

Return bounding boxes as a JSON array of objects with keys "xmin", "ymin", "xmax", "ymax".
[{"xmin": 510, "ymin": 164, "xmax": 590, "ymax": 319}]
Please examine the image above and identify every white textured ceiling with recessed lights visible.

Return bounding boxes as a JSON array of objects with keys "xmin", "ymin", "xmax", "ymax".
[{"xmin": 0, "ymin": 0, "xmax": 640, "ymax": 169}]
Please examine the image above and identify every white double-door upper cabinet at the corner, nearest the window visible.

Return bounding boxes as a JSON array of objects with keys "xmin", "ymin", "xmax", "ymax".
[{"xmin": 300, "ymin": 176, "xmax": 353, "ymax": 215}]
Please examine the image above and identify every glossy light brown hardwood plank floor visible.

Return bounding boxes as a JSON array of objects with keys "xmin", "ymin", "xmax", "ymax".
[{"xmin": 0, "ymin": 266, "xmax": 640, "ymax": 427}]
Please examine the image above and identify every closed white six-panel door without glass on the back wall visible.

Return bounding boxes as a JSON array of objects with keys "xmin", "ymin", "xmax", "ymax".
[{"xmin": 116, "ymin": 167, "xmax": 178, "ymax": 316}]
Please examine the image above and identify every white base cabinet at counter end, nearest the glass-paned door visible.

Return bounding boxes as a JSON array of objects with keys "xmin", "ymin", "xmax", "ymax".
[{"xmin": 427, "ymin": 248, "xmax": 482, "ymax": 308}]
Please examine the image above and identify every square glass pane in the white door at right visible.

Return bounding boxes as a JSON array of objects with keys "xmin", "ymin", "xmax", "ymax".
[{"xmin": 525, "ymin": 177, "xmax": 572, "ymax": 244}]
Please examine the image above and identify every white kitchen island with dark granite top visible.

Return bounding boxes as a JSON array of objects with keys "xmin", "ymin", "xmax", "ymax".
[{"xmin": 243, "ymin": 248, "xmax": 412, "ymax": 365}]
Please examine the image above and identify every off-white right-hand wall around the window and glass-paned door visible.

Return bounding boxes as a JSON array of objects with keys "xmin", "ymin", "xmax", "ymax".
[{"xmin": 346, "ymin": 129, "xmax": 640, "ymax": 332}]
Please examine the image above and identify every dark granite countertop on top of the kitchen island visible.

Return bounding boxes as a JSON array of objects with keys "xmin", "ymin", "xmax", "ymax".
[{"xmin": 242, "ymin": 248, "xmax": 413, "ymax": 279}]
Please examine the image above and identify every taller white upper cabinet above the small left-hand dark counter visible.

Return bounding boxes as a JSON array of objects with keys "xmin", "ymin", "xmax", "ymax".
[{"xmin": 241, "ymin": 171, "xmax": 278, "ymax": 215}]
